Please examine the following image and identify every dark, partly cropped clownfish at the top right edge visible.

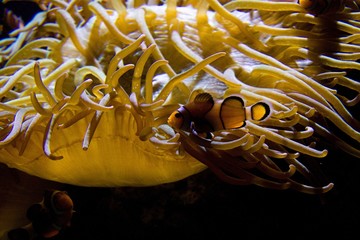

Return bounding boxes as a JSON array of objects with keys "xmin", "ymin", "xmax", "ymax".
[{"xmin": 298, "ymin": 0, "xmax": 359, "ymax": 15}]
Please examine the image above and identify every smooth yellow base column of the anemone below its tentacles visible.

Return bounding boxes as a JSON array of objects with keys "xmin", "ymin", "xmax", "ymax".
[{"xmin": 0, "ymin": 111, "xmax": 205, "ymax": 187}]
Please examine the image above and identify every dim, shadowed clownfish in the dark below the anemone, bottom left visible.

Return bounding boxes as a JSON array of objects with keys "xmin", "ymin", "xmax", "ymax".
[{"xmin": 27, "ymin": 190, "xmax": 74, "ymax": 238}]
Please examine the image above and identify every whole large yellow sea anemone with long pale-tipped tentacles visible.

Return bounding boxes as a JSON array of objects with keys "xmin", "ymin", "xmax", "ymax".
[{"xmin": 0, "ymin": 0, "xmax": 360, "ymax": 196}]
